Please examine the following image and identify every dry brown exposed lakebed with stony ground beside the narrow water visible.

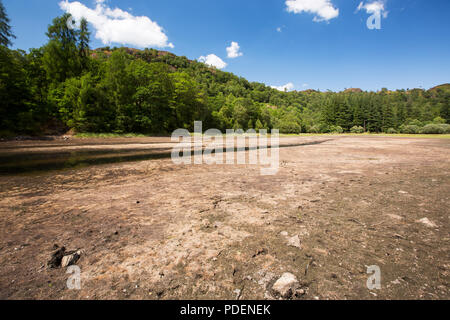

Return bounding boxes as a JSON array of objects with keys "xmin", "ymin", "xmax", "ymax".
[{"xmin": 0, "ymin": 136, "xmax": 450, "ymax": 299}]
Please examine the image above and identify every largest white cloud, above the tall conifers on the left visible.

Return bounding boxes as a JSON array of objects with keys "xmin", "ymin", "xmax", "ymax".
[{"xmin": 59, "ymin": 0, "xmax": 174, "ymax": 48}]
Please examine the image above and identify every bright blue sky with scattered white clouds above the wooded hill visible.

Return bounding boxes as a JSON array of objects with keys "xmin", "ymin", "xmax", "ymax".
[{"xmin": 3, "ymin": 0, "xmax": 450, "ymax": 91}]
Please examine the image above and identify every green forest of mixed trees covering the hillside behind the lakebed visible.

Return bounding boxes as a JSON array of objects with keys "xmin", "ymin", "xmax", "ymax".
[{"xmin": 0, "ymin": 2, "xmax": 450, "ymax": 136}]
